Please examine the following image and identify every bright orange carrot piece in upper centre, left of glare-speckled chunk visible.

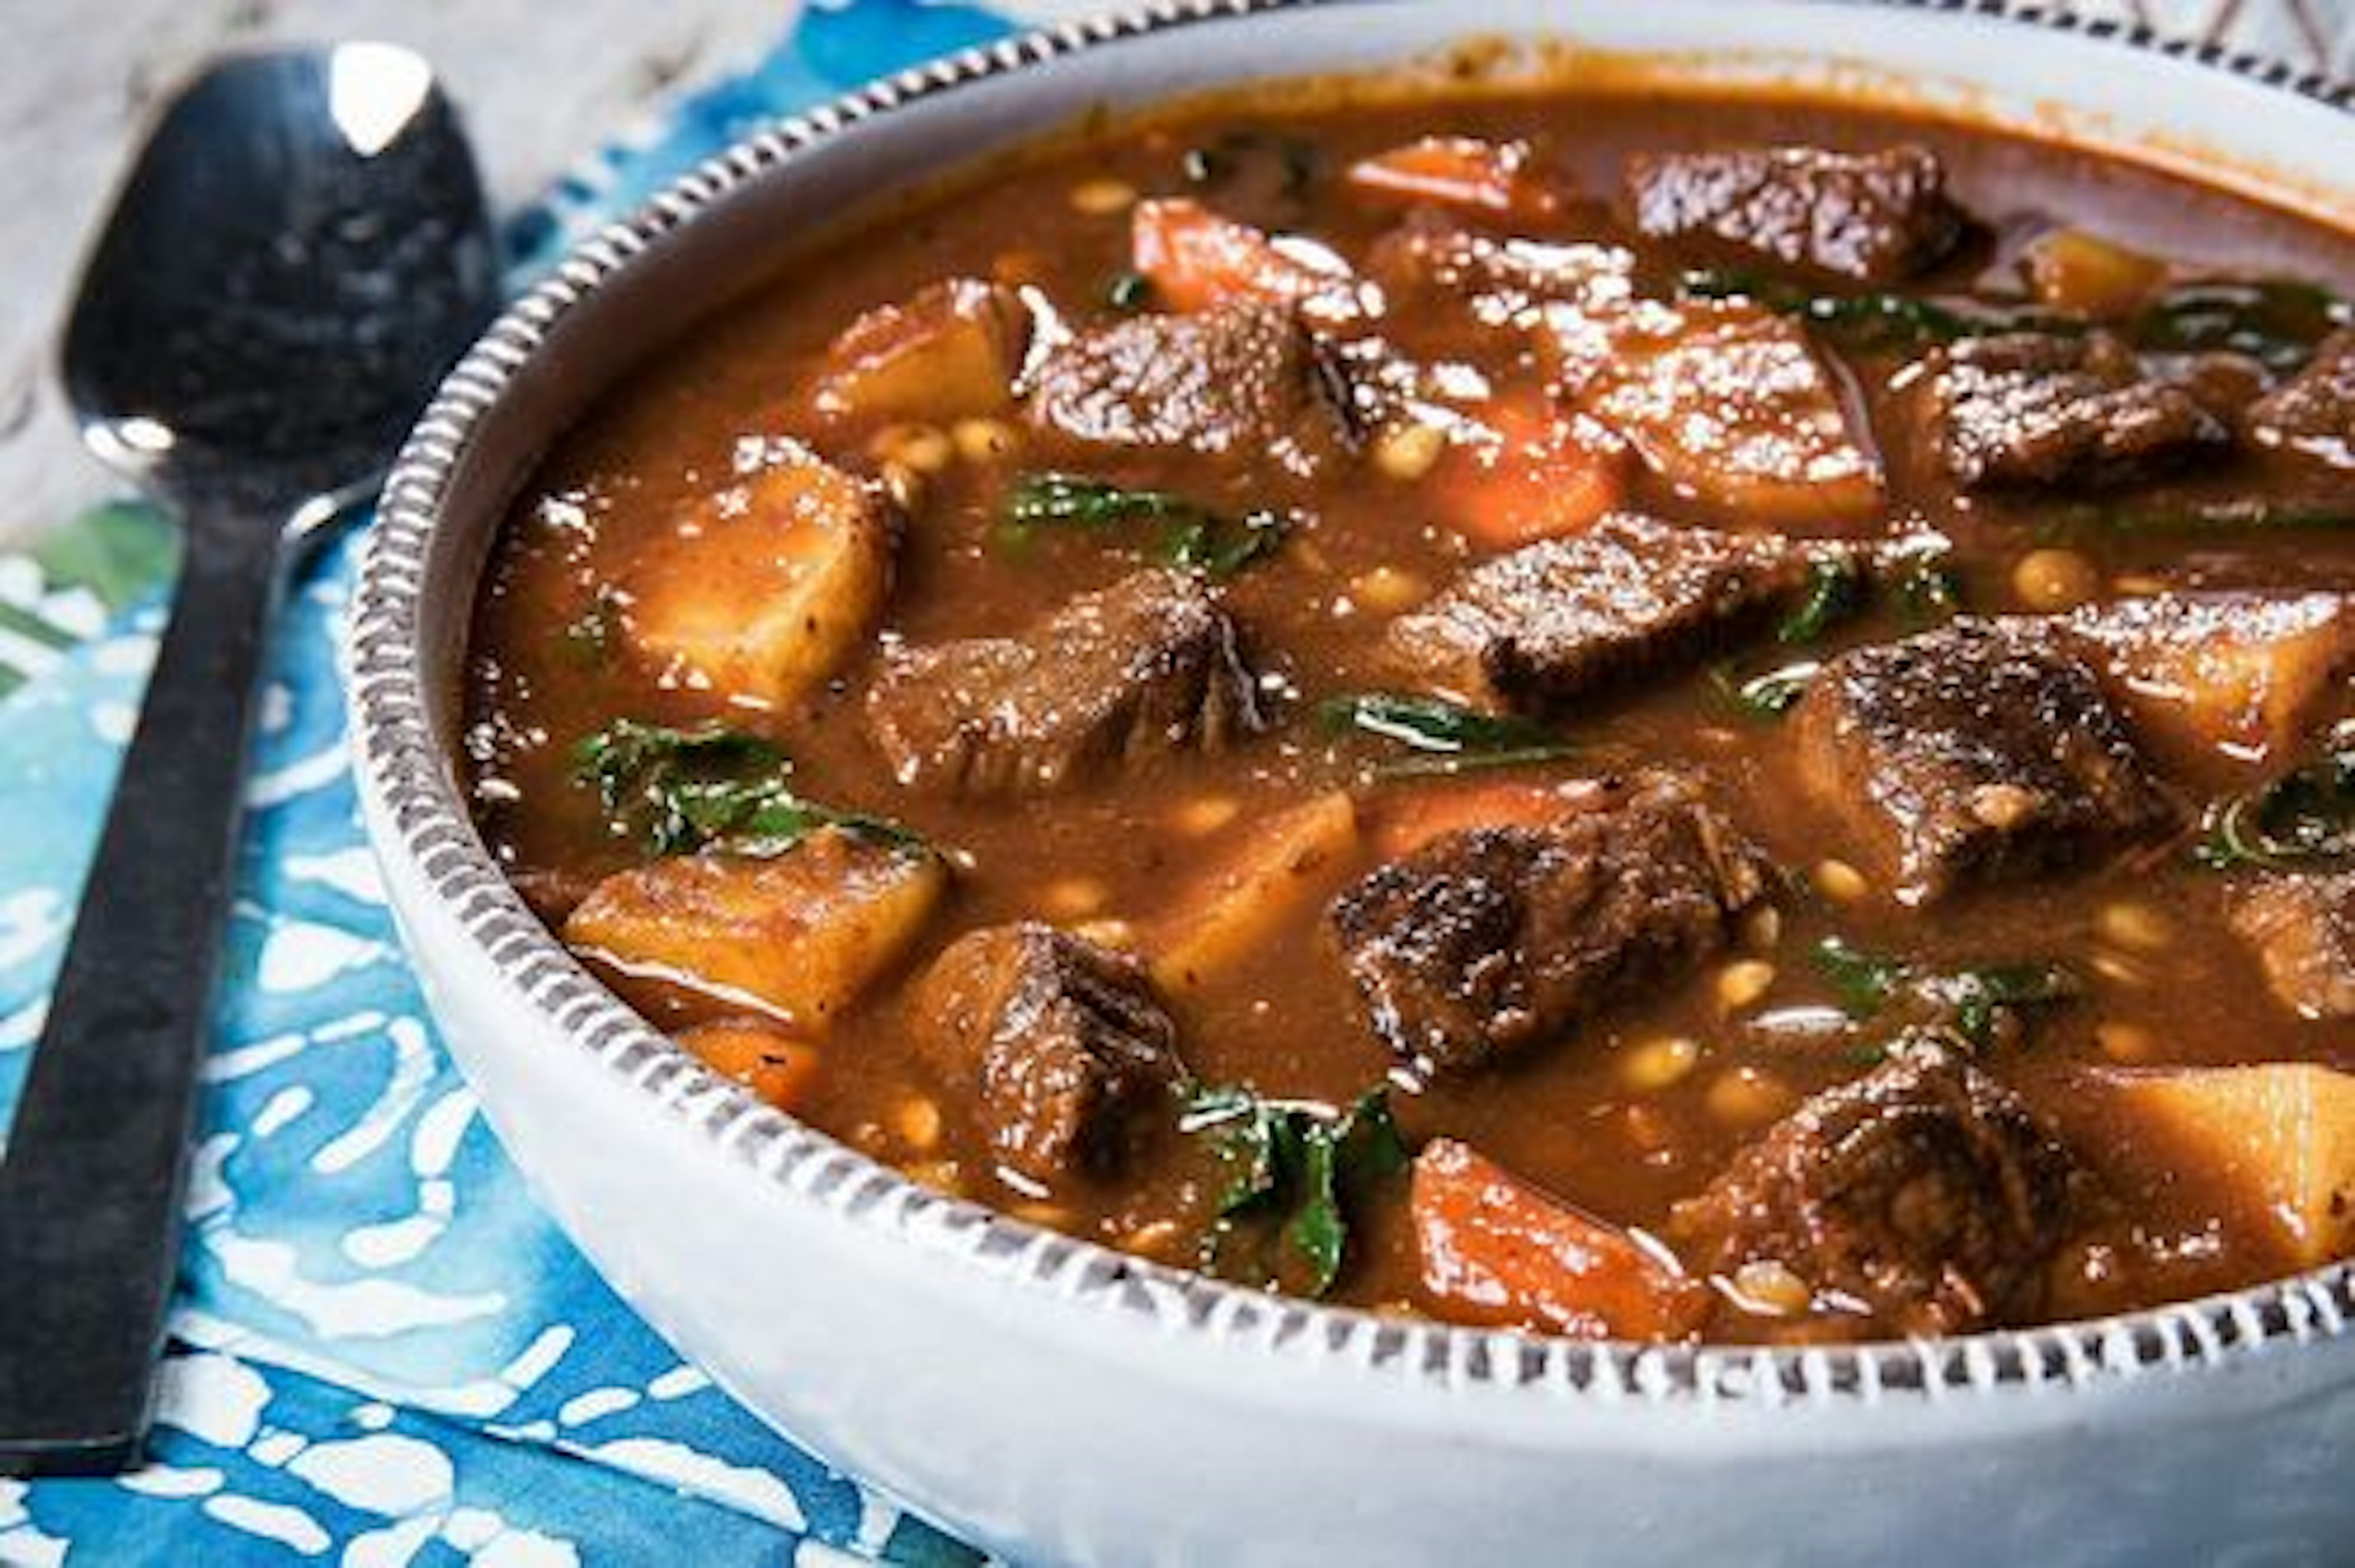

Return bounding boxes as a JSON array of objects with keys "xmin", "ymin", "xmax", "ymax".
[{"xmin": 1430, "ymin": 396, "xmax": 1629, "ymax": 551}]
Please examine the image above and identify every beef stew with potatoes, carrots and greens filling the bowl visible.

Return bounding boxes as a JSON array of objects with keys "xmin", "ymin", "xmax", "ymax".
[{"xmin": 464, "ymin": 94, "xmax": 2355, "ymax": 1340}]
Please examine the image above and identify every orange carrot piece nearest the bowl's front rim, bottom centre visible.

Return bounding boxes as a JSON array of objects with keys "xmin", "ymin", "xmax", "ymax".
[{"xmin": 1408, "ymin": 1137, "xmax": 1710, "ymax": 1340}]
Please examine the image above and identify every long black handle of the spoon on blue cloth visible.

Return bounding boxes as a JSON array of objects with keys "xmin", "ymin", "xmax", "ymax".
[{"xmin": 0, "ymin": 518, "xmax": 285, "ymax": 1474}]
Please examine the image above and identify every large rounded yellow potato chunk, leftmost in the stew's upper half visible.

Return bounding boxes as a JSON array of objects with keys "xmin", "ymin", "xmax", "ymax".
[{"xmin": 624, "ymin": 443, "xmax": 897, "ymax": 706}]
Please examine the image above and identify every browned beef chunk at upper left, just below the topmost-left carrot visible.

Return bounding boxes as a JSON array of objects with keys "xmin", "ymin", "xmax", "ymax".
[{"xmin": 1029, "ymin": 304, "xmax": 1347, "ymax": 473}]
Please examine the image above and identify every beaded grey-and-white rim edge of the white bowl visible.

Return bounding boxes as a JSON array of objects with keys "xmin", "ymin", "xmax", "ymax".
[{"xmin": 346, "ymin": 0, "xmax": 2355, "ymax": 1405}]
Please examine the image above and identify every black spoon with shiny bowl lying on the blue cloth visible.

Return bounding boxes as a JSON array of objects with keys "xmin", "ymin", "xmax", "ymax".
[{"xmin": 0, "ymin": 45, "xmax": 497, "ymax": 1474}]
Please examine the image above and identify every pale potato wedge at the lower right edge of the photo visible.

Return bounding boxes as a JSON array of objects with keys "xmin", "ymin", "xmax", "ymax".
[{"xmin": 2105, "ymin": 1062, "xmax": 2355, "ymax": 1264}]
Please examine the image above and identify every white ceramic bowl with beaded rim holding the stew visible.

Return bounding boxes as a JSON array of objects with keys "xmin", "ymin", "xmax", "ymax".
[{"xmin": 351, "ymin": 0, "xmax": 2355, "ymax": 1568}]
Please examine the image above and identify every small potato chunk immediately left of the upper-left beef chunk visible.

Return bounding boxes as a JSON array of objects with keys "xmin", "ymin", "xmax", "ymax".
[{"xmin": 813, "ymin": 278, "xmax": 1032, "ymax": 424}]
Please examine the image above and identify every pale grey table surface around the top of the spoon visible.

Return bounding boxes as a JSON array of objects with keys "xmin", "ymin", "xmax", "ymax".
[{"xmin": 0, "ymin": 0, "xmax": 796, "ymax": 549}]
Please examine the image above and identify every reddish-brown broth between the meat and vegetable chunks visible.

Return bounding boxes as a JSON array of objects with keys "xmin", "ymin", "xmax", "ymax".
[{"xmin": 466, "ymin": 85, "xmax": 2355, "ymax": 1337}]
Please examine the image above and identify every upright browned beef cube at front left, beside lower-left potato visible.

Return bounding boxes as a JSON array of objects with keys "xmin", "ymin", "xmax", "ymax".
[{"xmin": 914, "ymin": 923, "xmax": 1182, "ymax": 1182}]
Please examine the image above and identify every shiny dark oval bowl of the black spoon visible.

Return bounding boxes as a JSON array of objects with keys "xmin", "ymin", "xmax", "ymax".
[{"xmin": 64, "ymin": 42, "xmax": 497, "ymax": 525}]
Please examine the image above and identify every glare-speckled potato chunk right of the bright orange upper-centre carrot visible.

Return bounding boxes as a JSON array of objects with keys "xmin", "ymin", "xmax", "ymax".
[{"xmin": 1580, "ymin": 304, "xmax": 1882, "ymax": 525}]
